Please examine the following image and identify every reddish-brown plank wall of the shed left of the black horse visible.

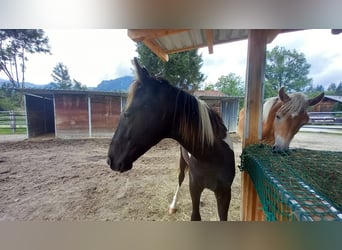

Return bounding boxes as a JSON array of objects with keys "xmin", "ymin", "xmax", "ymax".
[{"xmin": 55, "ymin": 94, "xmax": 121, "ymax": 138}]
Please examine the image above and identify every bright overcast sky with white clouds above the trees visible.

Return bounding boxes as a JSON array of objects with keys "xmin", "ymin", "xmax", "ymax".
[{"xmin": 0, "ymin": 29, "xmax": 342, "ymax": 87}]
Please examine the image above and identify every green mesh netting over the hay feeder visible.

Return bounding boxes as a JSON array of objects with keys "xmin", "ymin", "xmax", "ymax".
[{"xmin": 241, "ymin": 144, "xmax": 342, "ymax": 221}]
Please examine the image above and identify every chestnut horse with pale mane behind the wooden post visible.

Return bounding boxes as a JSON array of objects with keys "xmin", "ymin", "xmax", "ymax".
[{"xmin": 237, "ymin": 87, "xmax": 324, "ymax": 152}]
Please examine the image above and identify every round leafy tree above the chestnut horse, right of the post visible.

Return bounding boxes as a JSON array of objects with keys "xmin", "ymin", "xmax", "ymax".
[{"xmin": 265, "ymin": 46, "xmax": 312, "ymax": 98}]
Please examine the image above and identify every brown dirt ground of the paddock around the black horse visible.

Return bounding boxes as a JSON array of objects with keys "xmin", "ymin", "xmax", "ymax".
[{"xmin": 0, "ymin": 133, "xmax": 342, "ymax": 221}]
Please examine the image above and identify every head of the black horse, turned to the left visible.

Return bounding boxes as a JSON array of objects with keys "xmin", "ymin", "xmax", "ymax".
[{"xmin": 107, "ymin": 58, "xmax": 172, "ymax": 172}]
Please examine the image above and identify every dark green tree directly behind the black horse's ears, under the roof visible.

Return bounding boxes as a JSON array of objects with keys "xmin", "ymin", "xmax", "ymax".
[{"xmin": 137, "ymin": 43, "xmax": 205, "ymax": 90}]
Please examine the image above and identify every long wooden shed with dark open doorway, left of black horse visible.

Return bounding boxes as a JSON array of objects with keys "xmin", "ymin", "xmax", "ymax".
[{"xmin": 21, "ymin": 89, "xmax": 127, "ymax": 138}]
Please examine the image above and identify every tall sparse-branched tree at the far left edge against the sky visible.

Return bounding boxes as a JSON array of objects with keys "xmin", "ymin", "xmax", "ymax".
[{"xmin": 0, "ymin": 29, "xmax": 50, "ymax": 88}]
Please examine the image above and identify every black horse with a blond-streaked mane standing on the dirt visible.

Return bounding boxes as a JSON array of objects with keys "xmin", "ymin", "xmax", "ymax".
[{"xmin": 107, "ymin": 58, "xmax": 235, "ymax": 220}]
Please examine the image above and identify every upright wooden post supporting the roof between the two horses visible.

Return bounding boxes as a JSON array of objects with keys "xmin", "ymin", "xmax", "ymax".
[{"xmin": 241, "ymin": 30, "xmax": 268, "ymax": 221}]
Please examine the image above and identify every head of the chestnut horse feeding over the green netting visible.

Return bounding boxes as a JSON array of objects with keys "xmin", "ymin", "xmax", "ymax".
[{"xmin": 270, "ymin": 87, "xmax": 324, "ymax": 151}]
